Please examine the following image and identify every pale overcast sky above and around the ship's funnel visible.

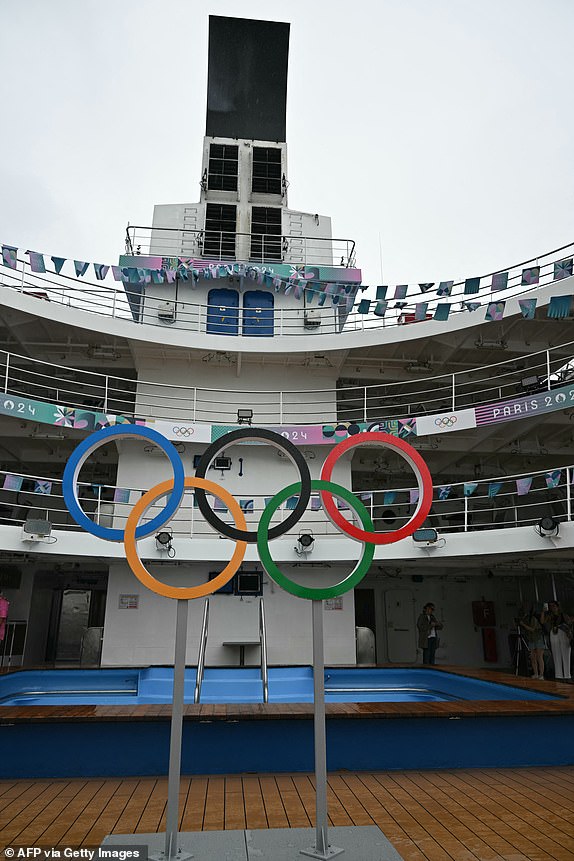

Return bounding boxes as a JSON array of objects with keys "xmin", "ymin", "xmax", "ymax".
[{"xmin": 0, "ymin": 0, "xmax": 574, "ymax": 284}]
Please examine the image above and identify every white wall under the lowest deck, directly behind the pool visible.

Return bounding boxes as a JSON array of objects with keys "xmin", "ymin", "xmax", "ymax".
[{"xmin": 102, "ymin": 563, "xmax": 355, "ymax": 666}]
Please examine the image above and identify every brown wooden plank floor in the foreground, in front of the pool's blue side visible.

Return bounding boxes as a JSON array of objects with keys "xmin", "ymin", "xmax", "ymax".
[{"xmin": 0, "ymin": 767, "xmax": 574, "ymax": 861}]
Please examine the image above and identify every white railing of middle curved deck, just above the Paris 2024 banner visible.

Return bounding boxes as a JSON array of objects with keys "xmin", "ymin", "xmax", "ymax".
[{"xmin": 0, "ymin": 341, "xmax": 574, "ymax": 429}]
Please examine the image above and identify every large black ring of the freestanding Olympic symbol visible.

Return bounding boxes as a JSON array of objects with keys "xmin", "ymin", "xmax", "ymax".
[{"xmin": 195, "ymin": 428, "xmax": 311, "ymax": 544}]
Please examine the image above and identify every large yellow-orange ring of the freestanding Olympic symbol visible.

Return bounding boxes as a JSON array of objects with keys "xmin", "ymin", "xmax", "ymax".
[{"xmin": 124, "ymin": 477, "xmax": 247, "ymax": 599}]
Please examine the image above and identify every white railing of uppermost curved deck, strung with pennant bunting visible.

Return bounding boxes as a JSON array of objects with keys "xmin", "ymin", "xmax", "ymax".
[{"xmin": 0, "ymin": 243, "xmax": 574, "ymax": 343}]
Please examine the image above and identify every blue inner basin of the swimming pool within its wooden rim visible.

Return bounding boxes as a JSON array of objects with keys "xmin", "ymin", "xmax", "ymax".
[{"xmin": 0, "ymin": 667, "xmax": 556, "ymax": 706}]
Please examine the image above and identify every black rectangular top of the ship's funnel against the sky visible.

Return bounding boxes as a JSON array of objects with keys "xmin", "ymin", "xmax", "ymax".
[{"xmin": 205, "ymin": 15, "xmax": 289, "ymax": 142}]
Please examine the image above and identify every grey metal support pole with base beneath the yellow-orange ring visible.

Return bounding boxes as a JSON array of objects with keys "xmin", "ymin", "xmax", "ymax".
[{"xmin": 150, "ymin": 598, "xmax": 193, "ymax": 861}]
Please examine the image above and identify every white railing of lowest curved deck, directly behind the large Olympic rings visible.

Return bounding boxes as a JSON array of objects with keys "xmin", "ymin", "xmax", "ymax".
[{"xmin": 0, "ymin": 465, "xmax": 574, "ymax": 536}]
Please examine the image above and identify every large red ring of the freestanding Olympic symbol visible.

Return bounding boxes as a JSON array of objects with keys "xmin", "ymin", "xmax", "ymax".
[{"xmin": 320, "ymin": 431, "xmax": 433, "ymax": 544}]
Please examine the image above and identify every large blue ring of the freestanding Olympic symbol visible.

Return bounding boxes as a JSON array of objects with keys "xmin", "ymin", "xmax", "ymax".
[{"xmin": 62, "ymin": 425, "xmax": 185, "ymax": 541}]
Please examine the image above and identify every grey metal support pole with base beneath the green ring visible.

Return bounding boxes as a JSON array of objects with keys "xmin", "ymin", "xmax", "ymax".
[{"xmin": 301, "ymin": 601, "xmax": 345, "ymax": 861}]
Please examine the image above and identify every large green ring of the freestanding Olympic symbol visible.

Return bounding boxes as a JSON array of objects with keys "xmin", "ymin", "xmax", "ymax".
[{"xmin": 257, "ymin": 478, "xmax": 375, "ymax": 601}]
